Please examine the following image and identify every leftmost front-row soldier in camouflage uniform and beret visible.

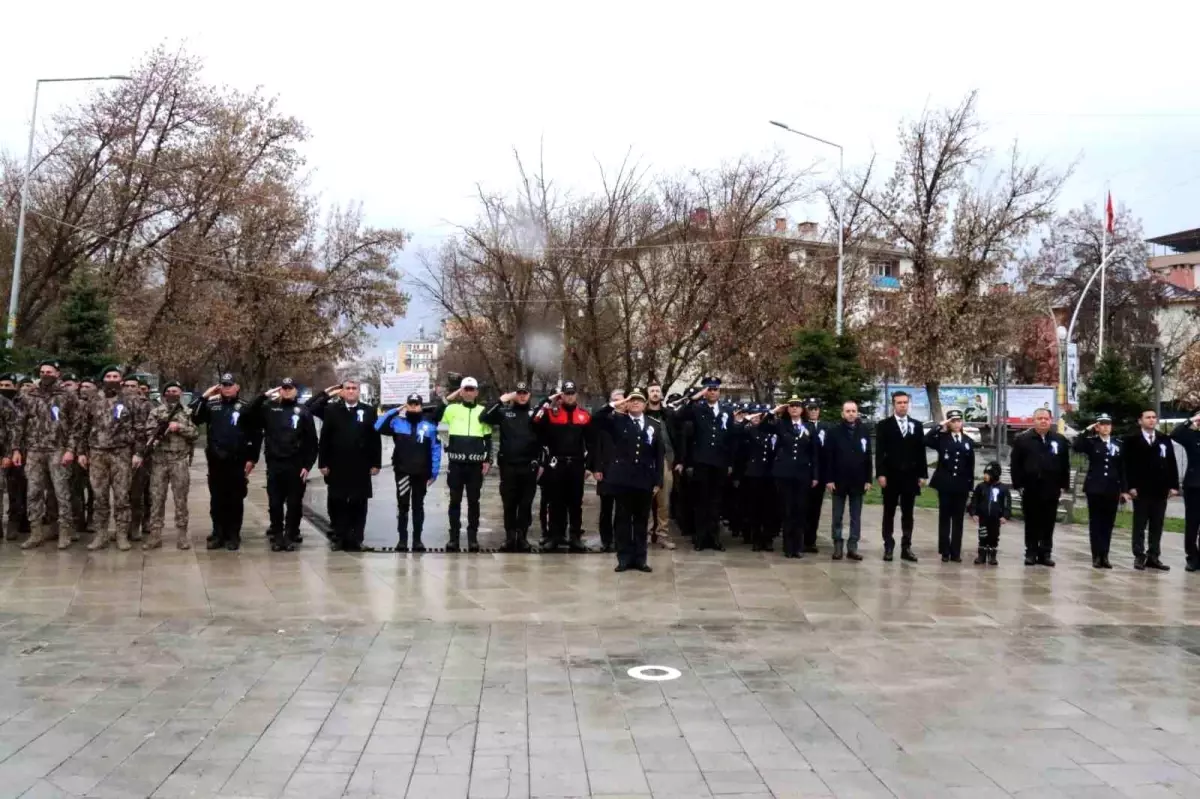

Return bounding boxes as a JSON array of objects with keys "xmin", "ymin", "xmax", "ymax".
[{"xmin": 12, "ymin": 360, "xmax": 79, "ymax": 549}]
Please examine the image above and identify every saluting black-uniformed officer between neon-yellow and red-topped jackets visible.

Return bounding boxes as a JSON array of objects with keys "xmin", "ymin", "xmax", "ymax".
[{"xmin": 479, "ymin": 383, "xmax": 541, "ymax": 552}]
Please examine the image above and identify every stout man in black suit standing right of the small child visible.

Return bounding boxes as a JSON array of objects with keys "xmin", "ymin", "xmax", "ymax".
[{"xmin": 1008, "ymin": 408, "xmax": 1070, "ymax": 566}]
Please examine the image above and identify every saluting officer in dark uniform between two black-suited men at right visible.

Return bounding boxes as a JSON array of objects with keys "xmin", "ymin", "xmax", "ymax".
[{"xmin": 1072, "ymin": 414, "xmax": 1129, "ymax": 569}]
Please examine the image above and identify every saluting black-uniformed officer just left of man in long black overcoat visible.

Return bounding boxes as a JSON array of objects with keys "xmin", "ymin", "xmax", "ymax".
[{"xmin": 246, "ymin": 378, "xmax": 317, "ymax": 552}]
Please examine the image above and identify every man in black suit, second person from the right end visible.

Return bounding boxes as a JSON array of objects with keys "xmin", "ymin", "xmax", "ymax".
[{"xmin": 1126, "ymin": 410, "xmax": 1180, "ymax": 571}]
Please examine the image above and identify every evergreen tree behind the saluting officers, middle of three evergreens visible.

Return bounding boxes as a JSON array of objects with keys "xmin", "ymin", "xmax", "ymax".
[{"xmin": 788, "ymin": 329, "xmax": 875, "ymax": 419}]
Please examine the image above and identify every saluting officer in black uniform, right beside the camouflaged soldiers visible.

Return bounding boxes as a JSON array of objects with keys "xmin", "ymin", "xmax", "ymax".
[{"xmin": 192, "ymin": 372, "xmax": 259, "ymax": 552}]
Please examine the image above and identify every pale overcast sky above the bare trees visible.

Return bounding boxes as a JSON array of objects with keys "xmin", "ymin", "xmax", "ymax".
[{"xmin": 0, "ymin": 0, "xmax": 1200, "ymax": 355}]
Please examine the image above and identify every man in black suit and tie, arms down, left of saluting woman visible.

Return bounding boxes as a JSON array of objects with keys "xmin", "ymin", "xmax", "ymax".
[{"xmin": 875, "ymin": 391, "xmax": 926, "ymax": 563}]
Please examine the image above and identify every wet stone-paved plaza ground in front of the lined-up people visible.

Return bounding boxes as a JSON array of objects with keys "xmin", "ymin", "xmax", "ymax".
[{"xmin": 0, "ymin": 470, "xmax": 1200, "ymax": 799}]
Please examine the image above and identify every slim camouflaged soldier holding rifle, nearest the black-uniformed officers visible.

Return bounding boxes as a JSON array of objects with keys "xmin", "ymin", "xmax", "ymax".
[{"xmin": 142, "ymin": 382, "xmax": 199, "ymax": 549}]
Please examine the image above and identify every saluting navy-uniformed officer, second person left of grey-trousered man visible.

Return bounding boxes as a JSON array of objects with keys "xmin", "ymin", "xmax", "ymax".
[{"xmin": 762, "ymin": 397, "xmax": 821, "ymax": 558}]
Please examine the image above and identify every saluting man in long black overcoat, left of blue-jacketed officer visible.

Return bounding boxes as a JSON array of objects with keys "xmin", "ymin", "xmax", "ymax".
[{"xmin": 308, "ymin": 380, "xmax": 382, "ymax": 552}]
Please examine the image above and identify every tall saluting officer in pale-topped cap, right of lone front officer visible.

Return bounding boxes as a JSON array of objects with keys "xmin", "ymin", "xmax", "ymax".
[{"xmin": 678, "ymin": 377, "xmax": 736, "ymax": 552}]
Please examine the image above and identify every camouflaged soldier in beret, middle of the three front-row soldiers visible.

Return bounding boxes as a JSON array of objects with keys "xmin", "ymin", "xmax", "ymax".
[{"xmin": 78, "ymin": 366, "xmax": 149, "ymax": 552}]
